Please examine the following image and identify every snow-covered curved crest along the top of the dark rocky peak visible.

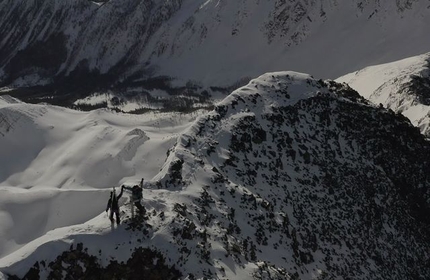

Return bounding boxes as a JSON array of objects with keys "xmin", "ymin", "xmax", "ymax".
[{"xmin": 154, "ymin": 71, "xmax": 329, "ymax": 187}]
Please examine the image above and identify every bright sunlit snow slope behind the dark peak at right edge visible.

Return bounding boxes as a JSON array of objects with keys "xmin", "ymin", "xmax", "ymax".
[{"xmin": 336, "ymin": 53, "xmax": 430, "ymax": 136}]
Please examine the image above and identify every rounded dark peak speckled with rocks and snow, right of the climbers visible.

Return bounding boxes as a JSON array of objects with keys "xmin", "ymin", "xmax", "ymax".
[{"xmin": 151, "ymin": 72, "xmax": 429, "ymax": 279}]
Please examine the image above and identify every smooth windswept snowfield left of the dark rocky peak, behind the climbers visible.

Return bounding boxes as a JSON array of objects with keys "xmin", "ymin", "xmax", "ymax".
[{"xmin": 0, "ymin": 96, "xmax": 198, "ymax": 267}]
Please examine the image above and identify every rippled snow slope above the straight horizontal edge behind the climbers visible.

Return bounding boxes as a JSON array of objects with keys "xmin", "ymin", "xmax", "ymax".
[{"xmin": 0, "ymin": 97, "xmax": 190, "ymax": 188}]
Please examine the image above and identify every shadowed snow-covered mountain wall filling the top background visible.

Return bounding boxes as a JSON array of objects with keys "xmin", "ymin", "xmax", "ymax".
[{"xmin": 0, "ymin": 0, "xmax": 430, "ymax": 104}]
